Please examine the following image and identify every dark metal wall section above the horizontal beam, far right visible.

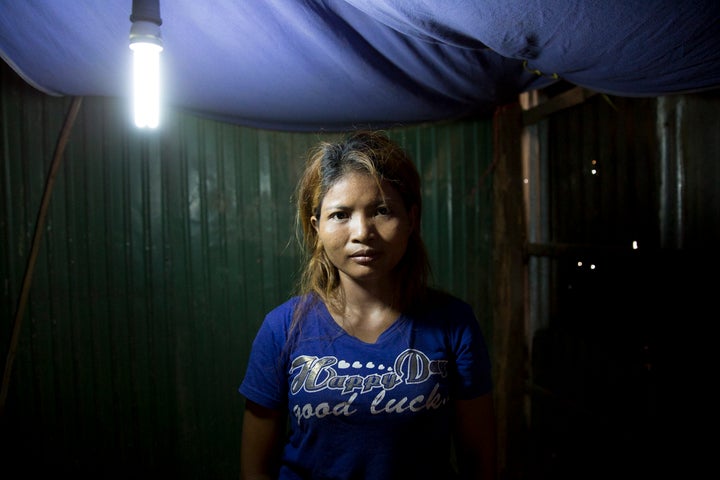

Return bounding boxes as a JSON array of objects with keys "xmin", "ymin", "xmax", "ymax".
[{"xmin": 546, "ymin": 91, "xmax": 720, "ymax": 250}]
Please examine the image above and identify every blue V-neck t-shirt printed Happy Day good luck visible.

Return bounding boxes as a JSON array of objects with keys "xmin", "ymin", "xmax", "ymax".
[{"xmin": 239, "ymin": 290, "xmax": 491, "ymax": 480}]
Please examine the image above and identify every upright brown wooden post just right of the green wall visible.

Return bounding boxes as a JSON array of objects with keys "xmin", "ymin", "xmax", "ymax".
[{"xmin": 492, "ymin": 103, "xmax": 529, "ymax": 480}]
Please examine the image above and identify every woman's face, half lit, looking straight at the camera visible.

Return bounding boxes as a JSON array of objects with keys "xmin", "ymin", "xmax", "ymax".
[{"xmin": 311, "ymin": 173, "xmax": 417, "ymax": 284}]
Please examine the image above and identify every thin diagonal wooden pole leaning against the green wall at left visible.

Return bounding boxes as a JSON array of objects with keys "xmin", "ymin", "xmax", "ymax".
[{"xmin": 0, "ymin": 97, "xmax": 82, "ymax": 418}]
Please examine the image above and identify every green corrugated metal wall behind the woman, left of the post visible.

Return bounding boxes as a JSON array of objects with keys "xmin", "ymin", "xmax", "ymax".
[{"xmin": 0, "ymin": 65, "xmax": 492, "ymax": 479}]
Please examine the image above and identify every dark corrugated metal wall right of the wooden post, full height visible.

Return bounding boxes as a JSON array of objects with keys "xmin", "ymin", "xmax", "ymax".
[{"xmin": 529, "ymin": 88, "xmax": 720, "ymax": 479}]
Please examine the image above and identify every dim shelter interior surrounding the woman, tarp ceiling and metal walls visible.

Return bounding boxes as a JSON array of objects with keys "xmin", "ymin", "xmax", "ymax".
[{"xmin": 0, "ymin": 0, "xmax": 720, "ymax": 480}]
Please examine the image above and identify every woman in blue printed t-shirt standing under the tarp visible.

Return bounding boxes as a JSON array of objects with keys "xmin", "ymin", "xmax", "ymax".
[{"xmin": 240, "ymin": 131, "xmax": 495, "ymax": 480}]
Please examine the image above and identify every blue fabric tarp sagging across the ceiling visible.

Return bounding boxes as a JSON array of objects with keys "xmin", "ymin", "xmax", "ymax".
[{"xmin": 0, "ymin": 0, "xmax": 720, "ymax": 131}]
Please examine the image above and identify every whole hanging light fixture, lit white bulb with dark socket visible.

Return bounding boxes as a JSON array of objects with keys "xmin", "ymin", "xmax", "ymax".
[{"xmin": 130, "ymin": 0, "xmax": 163, "ymax": 128}]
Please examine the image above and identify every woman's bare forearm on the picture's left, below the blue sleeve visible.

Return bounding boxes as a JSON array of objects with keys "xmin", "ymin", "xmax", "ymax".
[{"xmin": 240, "ymin": 400, "xmax": 285, "ymax": 480}]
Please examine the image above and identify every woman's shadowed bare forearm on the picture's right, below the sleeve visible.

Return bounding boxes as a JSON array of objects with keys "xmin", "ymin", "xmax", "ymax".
[{"xmin": 455, "ymin": 393, "xmax": 497, "ymax": 480}]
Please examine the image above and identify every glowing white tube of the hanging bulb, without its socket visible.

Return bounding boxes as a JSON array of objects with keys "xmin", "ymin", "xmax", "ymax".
[{"xmin": 130, "ymin": 42, "xmax": 162, "ymax": 128}]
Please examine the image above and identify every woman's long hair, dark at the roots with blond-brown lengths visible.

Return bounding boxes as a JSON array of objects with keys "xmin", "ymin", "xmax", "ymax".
[{"xmin": 296, "ymin": 130, "xmax": 430, "ymax": 316}]
